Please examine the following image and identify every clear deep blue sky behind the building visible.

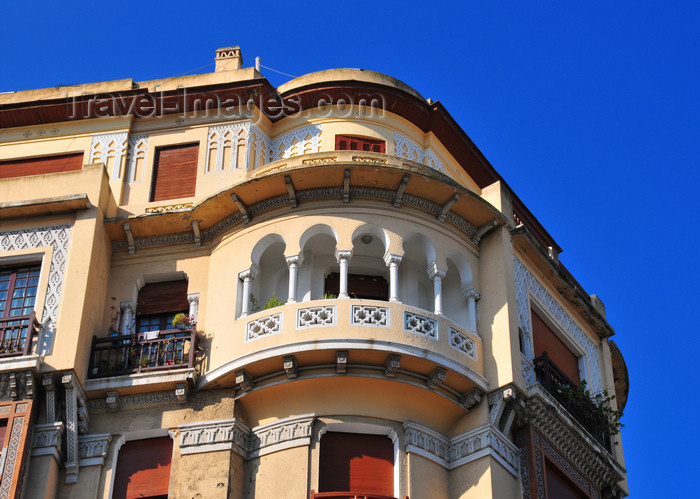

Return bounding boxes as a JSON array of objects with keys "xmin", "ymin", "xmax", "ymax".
[{"xmin": 0, "ymin": 1, "xmax": 700, "ymax": 498}]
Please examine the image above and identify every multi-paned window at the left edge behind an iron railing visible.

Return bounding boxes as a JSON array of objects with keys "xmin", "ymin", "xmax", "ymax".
[{"xmin": 0, "ymin": 265, "xmax": 41, "ymax": 355}]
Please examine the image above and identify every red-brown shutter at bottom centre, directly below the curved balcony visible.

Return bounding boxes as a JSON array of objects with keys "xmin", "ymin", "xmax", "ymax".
[{"xmin": 319, "ymin": 432, "xmax": 394, "ymax": 496}]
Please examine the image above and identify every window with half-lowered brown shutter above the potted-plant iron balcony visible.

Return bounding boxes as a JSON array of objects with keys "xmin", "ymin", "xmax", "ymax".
[{"xmin": 136, "ymin": 280, "xmax": 189, "ymax": 333}]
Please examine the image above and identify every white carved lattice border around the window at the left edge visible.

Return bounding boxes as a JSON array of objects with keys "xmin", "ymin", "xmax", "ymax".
[{"xmin": 0, "ymin": 224, "xmax": 72, "ymax": 355}]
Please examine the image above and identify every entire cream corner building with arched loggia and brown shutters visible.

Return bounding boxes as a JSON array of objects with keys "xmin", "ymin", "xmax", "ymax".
[{"xmin": 0, "ymin": 47, "xmax": 628, "ymax": 499}]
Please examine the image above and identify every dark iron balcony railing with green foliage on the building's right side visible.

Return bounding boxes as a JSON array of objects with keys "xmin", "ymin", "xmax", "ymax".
[{"xmin": 533, "ymin": 352, "xmax": 612, "ymax": 452}]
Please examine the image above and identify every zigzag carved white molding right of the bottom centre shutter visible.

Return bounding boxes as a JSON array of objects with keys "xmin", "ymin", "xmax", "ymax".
[{"xmin": 403, "ymin": 421, "xmax": 520, "ymax": 478}]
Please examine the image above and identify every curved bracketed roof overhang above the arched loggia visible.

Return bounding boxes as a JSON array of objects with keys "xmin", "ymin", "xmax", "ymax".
[{"xmin": 105, "ymin": 151, "xmax": 507, "ymax": 249}]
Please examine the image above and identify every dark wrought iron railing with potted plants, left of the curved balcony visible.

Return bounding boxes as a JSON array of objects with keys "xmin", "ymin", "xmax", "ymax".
[{"xmin": 88, "ymin": 327, "xmax": 197, "ymax": 378}]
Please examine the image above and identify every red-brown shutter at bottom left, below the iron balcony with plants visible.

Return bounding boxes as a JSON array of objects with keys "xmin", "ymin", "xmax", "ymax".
[{"xmin": 112, "ymin": 437, "xmax": 173, "ymax": 499}]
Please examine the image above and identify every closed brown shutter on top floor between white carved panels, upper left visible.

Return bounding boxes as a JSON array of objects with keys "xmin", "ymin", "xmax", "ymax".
[{"xmin": 151, "ymin": 144, "xmax": 199, "ymax": 201}]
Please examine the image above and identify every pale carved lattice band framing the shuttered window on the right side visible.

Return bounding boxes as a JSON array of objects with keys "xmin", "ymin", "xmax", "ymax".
[{"xmin": 513, "ymin": 256, "xmax": 603, "ymax": 393}]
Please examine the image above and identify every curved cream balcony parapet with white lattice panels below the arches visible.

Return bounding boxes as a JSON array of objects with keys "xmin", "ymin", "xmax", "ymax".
[{"xmin": 198, "ymin": 298, "xmax": 487, "ymax": 412}]
